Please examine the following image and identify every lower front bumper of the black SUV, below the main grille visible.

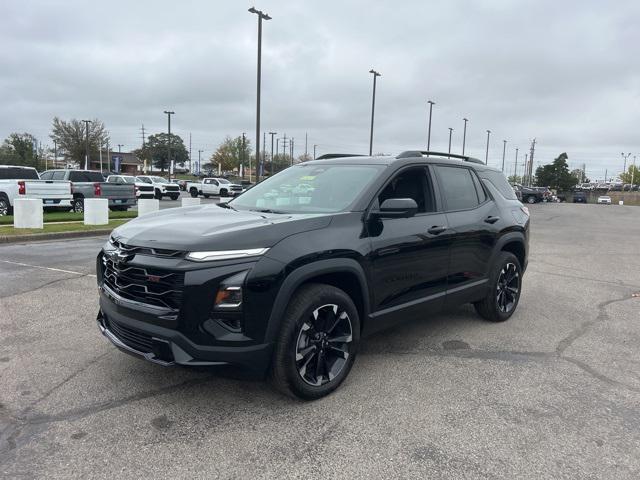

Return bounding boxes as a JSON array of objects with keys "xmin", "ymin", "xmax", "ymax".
[{"xmin": 97, "ymin": 290, "xmax": 272, "ymax": 375}]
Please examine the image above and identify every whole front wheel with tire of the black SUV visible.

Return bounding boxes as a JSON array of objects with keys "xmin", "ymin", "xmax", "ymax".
[{"xmin": 271, "ymin": 284, "xmax": 360, "ymax": 400}]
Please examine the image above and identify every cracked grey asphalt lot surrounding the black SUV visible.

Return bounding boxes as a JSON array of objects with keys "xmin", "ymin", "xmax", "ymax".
[{"xmin": 0, "ymin": 201, "xmax": 640, "ymax": 479}]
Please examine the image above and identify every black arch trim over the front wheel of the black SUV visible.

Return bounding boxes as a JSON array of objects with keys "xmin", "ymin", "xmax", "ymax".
[{"xmin": 266, "ymin": 258, "xmax": 370, "ymax": 342}]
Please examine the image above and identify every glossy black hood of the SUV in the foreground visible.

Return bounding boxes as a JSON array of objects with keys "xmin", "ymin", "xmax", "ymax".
[{"xmin": 113, "ymin": 204, "xmax": 332, "ymax": 251}]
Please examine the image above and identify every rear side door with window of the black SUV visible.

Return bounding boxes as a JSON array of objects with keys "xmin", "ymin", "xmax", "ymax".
[{"xmin": 435, "ymin": 165, "xmax": 501, "ymax": 304}]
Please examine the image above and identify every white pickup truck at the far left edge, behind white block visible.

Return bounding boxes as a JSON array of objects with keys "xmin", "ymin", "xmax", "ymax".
[{"xmin": 0, "ymin": 165, "xmax": 73, "ymax": 216}]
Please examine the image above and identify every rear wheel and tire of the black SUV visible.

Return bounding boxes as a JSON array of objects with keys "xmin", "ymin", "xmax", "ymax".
[{"xmin": 473, "ymin": 252, "xmax": 522, "ymax": 322}]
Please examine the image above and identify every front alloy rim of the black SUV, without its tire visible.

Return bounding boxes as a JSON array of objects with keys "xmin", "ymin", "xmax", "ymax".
[{"xmin": 296, "ymin": 304, "xmax": 353, "ymax": 387}]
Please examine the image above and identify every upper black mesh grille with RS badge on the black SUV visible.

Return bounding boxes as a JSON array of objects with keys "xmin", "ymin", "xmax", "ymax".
[{"xmin": 102, "ymin": 254, "xmax": 184, "ymax": 310}]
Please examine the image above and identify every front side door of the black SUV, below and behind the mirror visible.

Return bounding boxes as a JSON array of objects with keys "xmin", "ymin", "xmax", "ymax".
[{"xmin": 368, "ymin": 166, "xmax": 451, "ymax": 330}]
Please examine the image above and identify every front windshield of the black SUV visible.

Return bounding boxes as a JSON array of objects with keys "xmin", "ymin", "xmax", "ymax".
[{"xmin": 229, "ymin": 164, "xmax": 385, "ymax": 213}]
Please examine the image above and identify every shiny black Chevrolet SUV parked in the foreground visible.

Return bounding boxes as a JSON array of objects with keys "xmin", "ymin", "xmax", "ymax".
[{"xmin": 97, "ymin": 151, "xmax": 529, "ymax": 399}]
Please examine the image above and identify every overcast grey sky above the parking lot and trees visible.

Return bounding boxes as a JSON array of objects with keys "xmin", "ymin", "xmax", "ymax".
[{"xmin": 0, "ymin": 0, "xmax": 640, "ymax": 178}]
